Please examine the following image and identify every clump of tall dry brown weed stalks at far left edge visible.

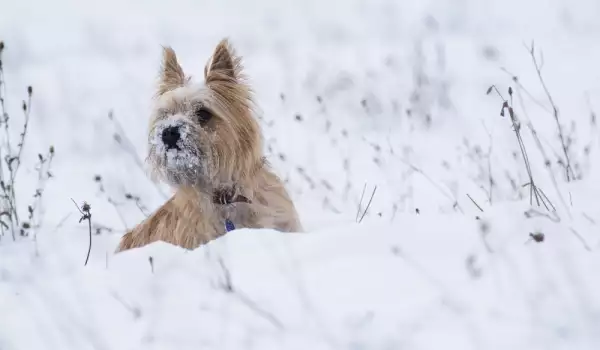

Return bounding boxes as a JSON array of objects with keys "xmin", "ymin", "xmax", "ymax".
[{"xmin": 0, "ymin": 41, "xmax": 54, "ymax": 240}]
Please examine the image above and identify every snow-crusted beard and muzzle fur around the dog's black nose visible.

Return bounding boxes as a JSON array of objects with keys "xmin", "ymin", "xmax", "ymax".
[{"xmin": 149, "ymin": 120, "xmax": 208, "ymax": 185}]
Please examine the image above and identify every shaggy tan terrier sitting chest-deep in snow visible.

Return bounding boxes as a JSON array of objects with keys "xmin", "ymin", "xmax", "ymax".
[{"xmin": 116, "ymin": 38, "xmax": 302, "ymax": 252}]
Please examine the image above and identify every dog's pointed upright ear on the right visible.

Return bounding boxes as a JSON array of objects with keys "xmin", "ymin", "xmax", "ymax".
[{"xmin": 204, "ymin": 38, "xmax": 242, "ymax": 84}]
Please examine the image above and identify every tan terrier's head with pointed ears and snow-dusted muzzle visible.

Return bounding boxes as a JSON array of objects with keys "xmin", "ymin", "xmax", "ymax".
[{"xmin": 148, "ymin": 39, "xmax": 262, "ymax": 187}]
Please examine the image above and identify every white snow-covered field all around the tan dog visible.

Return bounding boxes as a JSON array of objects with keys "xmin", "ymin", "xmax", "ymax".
[{"xmin": 0, "ymin": 0, "xmax": 600, "ymax": 350}]
